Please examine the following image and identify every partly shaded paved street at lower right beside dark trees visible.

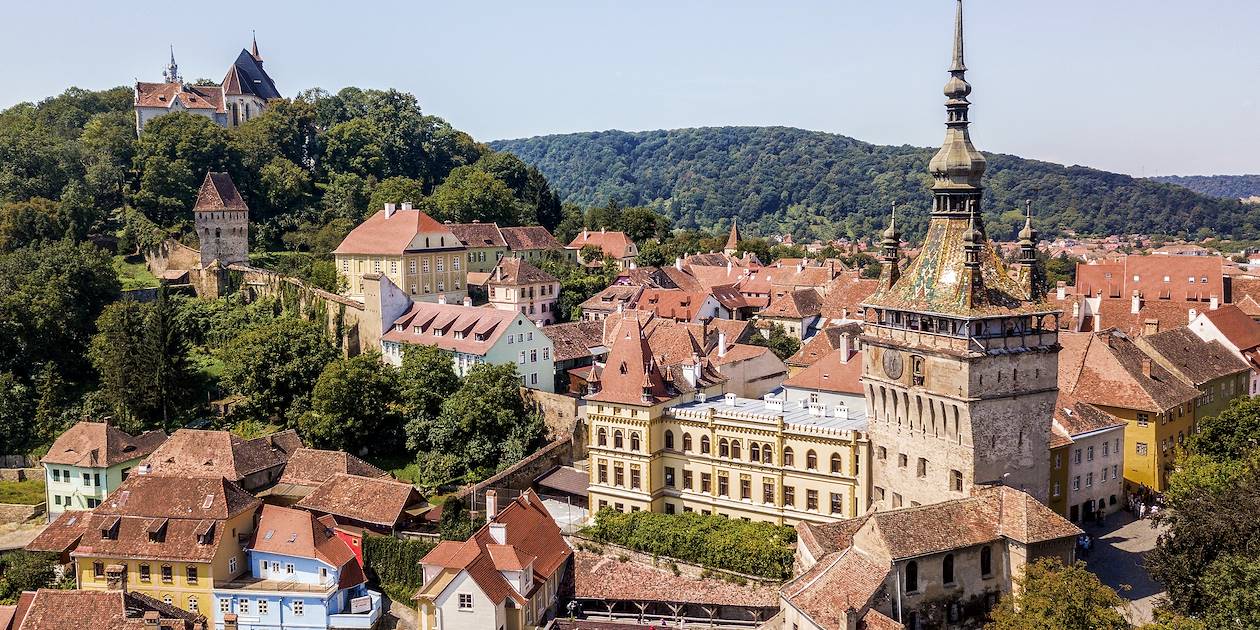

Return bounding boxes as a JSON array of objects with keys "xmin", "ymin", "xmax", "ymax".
[{"xmin": 1082, "ymin": 512, "xmax": 1163, "ymax": 625}]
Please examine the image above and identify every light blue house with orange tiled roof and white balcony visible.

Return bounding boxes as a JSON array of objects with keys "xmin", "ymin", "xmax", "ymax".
[{"xmin": 214, "ymin": 505, "xmax": 381, "ymax": 630}]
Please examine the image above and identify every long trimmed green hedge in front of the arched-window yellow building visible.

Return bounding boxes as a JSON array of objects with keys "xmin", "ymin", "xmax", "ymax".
[{"xmin": 583, "ymin": 508, "xmax": 796, "ymax": 580}]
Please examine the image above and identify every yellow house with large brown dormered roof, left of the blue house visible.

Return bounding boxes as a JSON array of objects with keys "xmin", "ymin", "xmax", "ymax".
[{"xmin": 59, "ymin": 475, "xmax": 261, "ymax": 620}]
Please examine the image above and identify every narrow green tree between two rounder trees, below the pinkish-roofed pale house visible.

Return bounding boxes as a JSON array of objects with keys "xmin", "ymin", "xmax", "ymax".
[{"xmin": 398, "ymin": 345, "xmax": 460, "ymax": 453}]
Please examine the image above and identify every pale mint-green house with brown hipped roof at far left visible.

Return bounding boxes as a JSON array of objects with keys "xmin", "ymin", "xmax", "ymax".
[{"xmin": 40, "ymin": 421, "xmax": 166, "ymax": 522}]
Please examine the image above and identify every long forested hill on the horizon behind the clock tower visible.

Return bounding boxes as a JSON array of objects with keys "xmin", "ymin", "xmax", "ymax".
[{"xmin": 491, "ymin": 127, "xmax": 1260, "ymax": 238}]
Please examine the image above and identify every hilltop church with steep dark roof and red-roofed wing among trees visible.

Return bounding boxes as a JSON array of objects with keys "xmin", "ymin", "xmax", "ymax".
[{"xmin": 134, "ymin": 38, "xmax": 280, "ymax": 134}]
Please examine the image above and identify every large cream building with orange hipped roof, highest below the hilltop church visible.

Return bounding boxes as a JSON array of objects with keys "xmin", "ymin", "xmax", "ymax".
[{"xmin": 333, "ymin": 203, "xmax": 469, "ymax": 302}]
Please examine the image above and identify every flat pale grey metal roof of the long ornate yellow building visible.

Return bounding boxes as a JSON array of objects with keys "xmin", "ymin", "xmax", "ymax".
[{"xmin": 669, "ymin": 388, "xmax": 867, "ymax": 431}]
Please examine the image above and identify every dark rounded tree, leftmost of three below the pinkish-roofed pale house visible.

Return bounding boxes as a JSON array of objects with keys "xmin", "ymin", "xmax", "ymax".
[{"xmin": 299, "ymin": 353, "xmax": 398, "ymax": 452}]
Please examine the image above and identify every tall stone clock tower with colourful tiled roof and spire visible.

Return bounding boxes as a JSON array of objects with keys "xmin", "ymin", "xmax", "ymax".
[{"xmin": 862, "ymin": 0, "xmax": 1058, "ymax": 508}]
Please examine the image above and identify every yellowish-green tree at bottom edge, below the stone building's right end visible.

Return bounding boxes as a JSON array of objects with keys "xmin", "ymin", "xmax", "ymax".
[{"xmin": 985, "ymin": 558, "xmax": 1129, "ymax": 630}]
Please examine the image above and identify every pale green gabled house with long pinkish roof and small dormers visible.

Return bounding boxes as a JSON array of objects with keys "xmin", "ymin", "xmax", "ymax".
[{"xmin": 381, "ymin": 297, "xmax": 556, "ymax": 392}]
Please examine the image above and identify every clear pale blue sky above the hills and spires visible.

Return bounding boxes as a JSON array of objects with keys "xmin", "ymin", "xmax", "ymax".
[{"xmin": 0, "ymin": 0, "xmax": 1260, "ymax": 176}]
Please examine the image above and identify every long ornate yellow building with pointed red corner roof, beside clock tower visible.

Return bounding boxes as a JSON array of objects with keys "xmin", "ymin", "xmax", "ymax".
[{"xmin": 586, "ymin": 318, "xmax": 869, "ymax": 524}]
